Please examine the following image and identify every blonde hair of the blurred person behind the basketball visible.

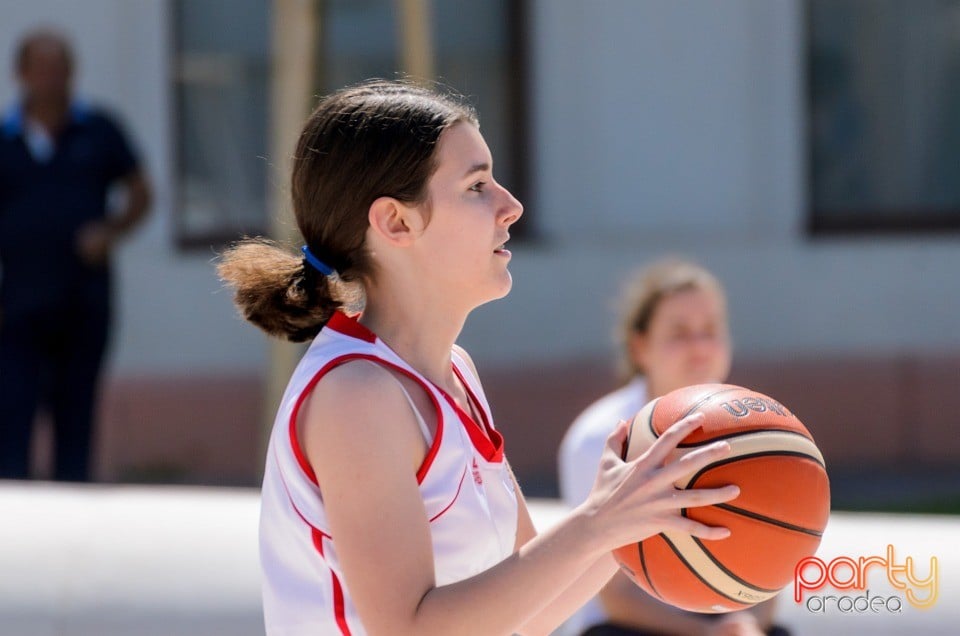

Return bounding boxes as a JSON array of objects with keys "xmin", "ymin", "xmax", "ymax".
[{"xmin": 617, "ymin": 257, "xmax": 726, "ymax": 381}]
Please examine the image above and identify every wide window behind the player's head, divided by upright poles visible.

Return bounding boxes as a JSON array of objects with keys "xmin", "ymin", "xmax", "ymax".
[{"xmin": 173, "ymin": 0, "xmax": 529, "ymax": 247}]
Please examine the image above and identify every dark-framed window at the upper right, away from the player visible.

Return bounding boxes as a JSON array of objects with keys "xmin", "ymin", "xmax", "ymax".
[{"xmin": 807, "ymin": 0, "xmax": 960, "ymax": 233}]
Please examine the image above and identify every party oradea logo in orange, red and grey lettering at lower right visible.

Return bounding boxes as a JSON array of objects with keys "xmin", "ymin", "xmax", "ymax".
[{"xmin": 793, "ymin": 545, "xmax": 940, "ymax": 614}]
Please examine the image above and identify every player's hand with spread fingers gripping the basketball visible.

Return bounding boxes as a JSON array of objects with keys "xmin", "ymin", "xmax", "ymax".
[{"xmin": 583, "ymin": 414, "xmax": 740, "ymax": 549}]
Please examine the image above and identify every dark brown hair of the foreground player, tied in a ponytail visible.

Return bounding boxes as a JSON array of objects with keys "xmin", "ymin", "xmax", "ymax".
[{"xmin": 217, "ymin": 80, "xmax": 477, "ymax": 342}]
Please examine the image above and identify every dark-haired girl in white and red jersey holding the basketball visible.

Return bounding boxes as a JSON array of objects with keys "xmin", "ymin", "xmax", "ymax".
[{"xmin": 219, "ymin": 82, "xmax": 738, "ymax": 636}]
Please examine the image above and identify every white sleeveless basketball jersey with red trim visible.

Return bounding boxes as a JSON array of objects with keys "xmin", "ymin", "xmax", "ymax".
[{"xmin": 260, "ymin": 313, "xmax": 517, "ymax": 636}]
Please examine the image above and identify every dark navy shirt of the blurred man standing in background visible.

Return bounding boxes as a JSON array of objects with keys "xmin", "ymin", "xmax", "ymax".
[{"xmin": 0, "ymin": 105, "xmax": 138, "ymax": 311}]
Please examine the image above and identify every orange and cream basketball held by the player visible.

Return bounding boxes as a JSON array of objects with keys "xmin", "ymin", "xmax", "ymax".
[{"xmin": 614, "ymin": 384, "xmax": 830, "ymax": 613}]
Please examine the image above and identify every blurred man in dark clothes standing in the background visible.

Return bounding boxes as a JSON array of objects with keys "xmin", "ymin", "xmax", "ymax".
[{"xmin": 0, "ymin": 30, "xmax": 150, "ymax": 481}]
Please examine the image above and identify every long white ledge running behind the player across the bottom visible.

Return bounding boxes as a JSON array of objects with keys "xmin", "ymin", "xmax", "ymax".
[{"xmin": 0, "ymin": 482, "xmax": 960, "ymax": 636}]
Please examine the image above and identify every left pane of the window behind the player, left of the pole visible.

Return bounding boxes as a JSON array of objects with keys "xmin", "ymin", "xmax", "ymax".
[{"xmin": 173, "ymin": 0, "xmax": 270, "ymax": 247}]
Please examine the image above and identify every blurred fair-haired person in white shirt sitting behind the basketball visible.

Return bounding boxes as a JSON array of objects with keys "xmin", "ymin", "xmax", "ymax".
[{"xmin": 558, "ymin": 259, "xmax": 787, "ymax": 636}]
